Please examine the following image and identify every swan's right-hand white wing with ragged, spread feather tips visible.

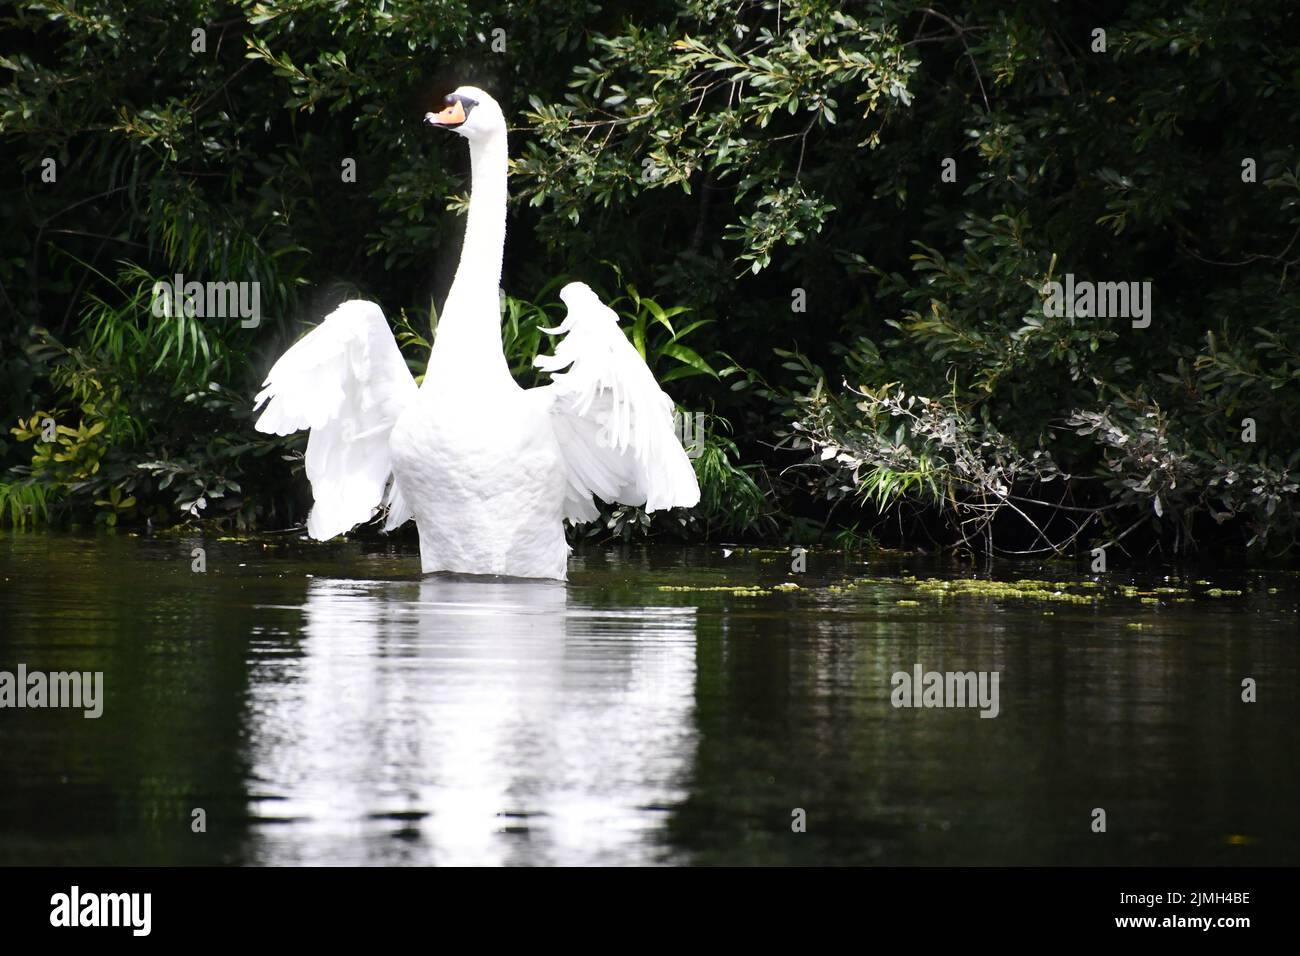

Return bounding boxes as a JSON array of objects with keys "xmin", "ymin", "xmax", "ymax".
[{"xmin": 534, "ymin": 282, "xmax": 699, "ymax": 522}]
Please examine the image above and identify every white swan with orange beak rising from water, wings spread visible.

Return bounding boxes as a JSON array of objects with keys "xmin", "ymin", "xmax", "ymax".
[{"xmin": 254, "ymin": 86, "xmax": 699, "ymax": 580}]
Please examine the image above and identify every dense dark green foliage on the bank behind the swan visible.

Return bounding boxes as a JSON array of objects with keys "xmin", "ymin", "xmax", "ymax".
[{"xmin": 0, "ymin": 0, "xmax": 1300, "ymax": 550}]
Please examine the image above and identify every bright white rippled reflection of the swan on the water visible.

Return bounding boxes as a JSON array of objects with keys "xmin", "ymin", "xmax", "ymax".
[{"xmin": 239, "ymin": 576, "xmax": 696, "ymax": 864}]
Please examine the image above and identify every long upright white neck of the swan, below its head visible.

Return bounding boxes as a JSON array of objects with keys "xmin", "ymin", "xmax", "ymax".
[{"xmin": 426, "ymin": 130, "xmax": 510, "ymax": 384}]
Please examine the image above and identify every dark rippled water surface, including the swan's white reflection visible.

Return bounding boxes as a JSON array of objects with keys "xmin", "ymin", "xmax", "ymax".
[{"xmin": 0, "ymin": 533, "xmax": 1300, "ymax": 865}]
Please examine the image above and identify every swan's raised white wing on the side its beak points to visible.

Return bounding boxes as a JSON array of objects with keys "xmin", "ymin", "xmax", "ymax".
[{"xmin": 254, "ymin": 299, "xmax": 416, "ymax": 540}]
